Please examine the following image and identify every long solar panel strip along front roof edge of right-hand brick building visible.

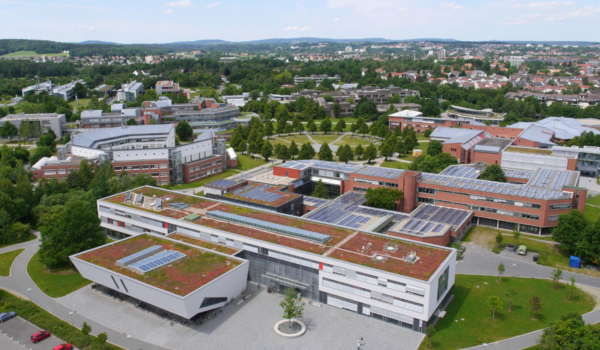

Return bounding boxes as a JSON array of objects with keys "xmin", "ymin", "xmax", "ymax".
[{"xmin": 422, "ymin": 173, "xmax": 570, "ymax": 199}]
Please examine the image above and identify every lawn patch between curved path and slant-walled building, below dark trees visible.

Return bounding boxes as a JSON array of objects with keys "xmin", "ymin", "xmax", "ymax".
[{"xmin": 27, "ymin": 253, "xmax": 92, "ymax": 298}]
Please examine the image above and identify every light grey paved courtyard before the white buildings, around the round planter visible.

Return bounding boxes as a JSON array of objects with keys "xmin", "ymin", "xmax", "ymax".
[{"xmin": 56, "ymin": 285, "xmax": 423, "ymax": 350}]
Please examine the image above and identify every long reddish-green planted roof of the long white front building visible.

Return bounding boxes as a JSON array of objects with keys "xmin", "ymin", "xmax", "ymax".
[{"xmin": 101, "ymin": 187, "xmax": 451, "ymax": 280}]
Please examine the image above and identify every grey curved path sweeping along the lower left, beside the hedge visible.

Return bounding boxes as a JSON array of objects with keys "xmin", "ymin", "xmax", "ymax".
[{"xmin": 0, "ymin": 232, "xmax": 166, "ymax": 350}]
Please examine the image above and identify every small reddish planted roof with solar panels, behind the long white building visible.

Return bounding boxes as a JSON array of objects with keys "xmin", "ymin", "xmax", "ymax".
[{"xmin": 223, "ymin": 182, "xmax": 302, "ymax": 208}]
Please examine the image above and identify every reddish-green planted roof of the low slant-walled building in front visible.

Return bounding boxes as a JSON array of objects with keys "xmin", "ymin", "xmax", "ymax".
[{"xmin": 75, "ymin": 234, "xmax": 242, "ymax": 296}]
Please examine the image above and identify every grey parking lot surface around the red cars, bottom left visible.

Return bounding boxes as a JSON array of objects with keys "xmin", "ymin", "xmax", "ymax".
[{"xmin": 0, "ymin": 317, "xmax": 70, "ymax": 350}]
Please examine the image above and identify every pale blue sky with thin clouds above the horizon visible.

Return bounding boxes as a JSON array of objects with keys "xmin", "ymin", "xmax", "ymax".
[{"xmin": 0, "ymin": 0, "xmax": 600, "ymax": 43}]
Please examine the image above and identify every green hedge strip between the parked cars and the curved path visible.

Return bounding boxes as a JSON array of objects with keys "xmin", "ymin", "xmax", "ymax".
[{"xmin": 0, "ymin": 290, "xmax": 121, "ymax": 350}]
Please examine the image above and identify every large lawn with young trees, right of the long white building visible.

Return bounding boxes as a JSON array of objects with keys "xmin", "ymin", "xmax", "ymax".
[{"xmin": 419, "ymin": 275, "xmax": 594, "ymax": 350}]
